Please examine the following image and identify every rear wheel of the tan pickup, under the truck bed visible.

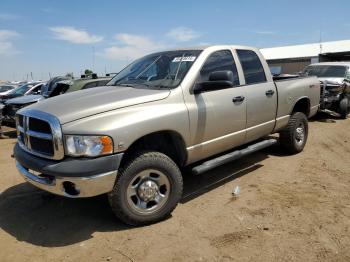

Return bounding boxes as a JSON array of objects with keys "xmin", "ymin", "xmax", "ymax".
[{"xmin": 280, "ymin": 112, "xmax": 309, "ymax": 154}]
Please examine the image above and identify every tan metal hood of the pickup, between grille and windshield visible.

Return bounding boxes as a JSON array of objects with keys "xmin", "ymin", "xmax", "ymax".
[{"xmin": 24, "ymin": 86, "xmax": 170, "ymax": 124}]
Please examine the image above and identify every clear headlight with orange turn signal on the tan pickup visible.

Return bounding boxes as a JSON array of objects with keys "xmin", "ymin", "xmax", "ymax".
[{"xmin": 66, "ymin": 135, "xmax": 113, "ymax": 157}]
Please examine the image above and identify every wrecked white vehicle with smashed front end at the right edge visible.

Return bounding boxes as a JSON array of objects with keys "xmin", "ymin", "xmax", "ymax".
[{"xmin": 303, "ymin": 62, "xmax": 350, "ymax": 118}]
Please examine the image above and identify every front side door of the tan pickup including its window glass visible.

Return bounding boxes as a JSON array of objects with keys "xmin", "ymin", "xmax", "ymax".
[{"xmin": 188, "ymin": 50, "xmax": 246, "ymax": 161}]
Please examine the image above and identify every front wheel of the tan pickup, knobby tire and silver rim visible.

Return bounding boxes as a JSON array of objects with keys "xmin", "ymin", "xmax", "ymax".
[{"xmin": 108, "ymin": 152, "xmax": 183, "ymax": 226}]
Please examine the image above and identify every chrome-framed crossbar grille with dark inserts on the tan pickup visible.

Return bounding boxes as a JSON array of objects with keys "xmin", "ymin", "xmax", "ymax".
[{"xmin": 16, "ymin": 109, "xmax": 64, "ymax": 160}]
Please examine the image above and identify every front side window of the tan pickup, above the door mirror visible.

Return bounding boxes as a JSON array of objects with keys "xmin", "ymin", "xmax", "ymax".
[{"xmin": 199, "ymin": 50, "xmax": 239, "ymax": 86}]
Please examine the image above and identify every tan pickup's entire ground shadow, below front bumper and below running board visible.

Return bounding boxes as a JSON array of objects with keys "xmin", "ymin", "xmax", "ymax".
[{"xmin": 0, "ymin": 147, "xmax": 283, "ymax": 247}]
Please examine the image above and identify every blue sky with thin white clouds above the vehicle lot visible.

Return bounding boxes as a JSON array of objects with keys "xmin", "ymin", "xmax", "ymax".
[{"xmin": 0, "ymin": 0, "xmax": 350, "ymax": 80}]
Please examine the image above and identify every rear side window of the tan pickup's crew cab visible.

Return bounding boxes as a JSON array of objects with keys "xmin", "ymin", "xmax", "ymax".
[{"xmin": 237, "ymin": 50, "xmax": 266, "ymax": 85}]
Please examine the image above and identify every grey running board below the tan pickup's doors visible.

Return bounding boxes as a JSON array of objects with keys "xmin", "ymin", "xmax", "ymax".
[{"xmin": 192, "ymin": 139, "xmax": 277, "ymax": 175}]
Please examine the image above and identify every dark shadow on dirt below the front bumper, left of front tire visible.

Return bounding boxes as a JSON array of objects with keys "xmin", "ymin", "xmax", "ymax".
[{"xmin": 0, "ymin": 183, "xmax": 129, "ymax": 247}]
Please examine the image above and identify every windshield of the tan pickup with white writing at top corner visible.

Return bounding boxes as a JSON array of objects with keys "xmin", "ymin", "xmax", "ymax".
[{"xmin": 107, "ymin": 50, "xmax": 201, "ymax": 88}]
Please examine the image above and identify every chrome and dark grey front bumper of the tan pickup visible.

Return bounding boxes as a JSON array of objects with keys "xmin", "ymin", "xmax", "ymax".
[{"xmin": 14, "ymin": 144, "xmax": 123, "ymax": 198}]
